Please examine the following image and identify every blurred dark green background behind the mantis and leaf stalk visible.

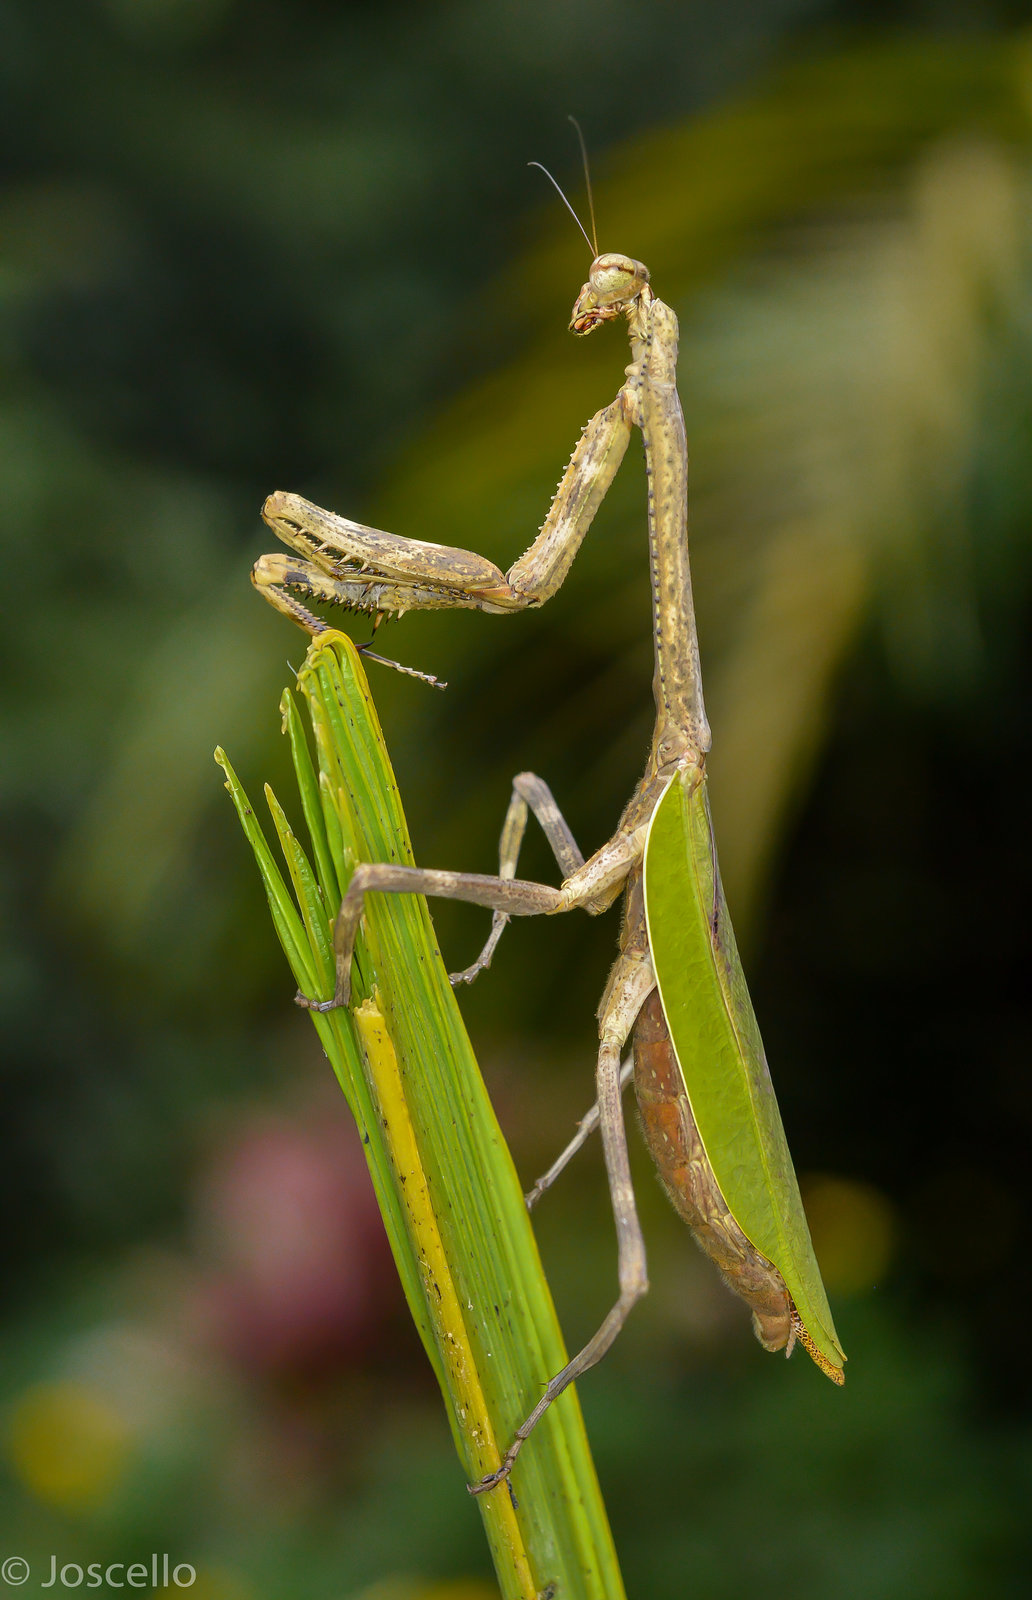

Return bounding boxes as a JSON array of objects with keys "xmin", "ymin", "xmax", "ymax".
[{"xmin": 0, "ymin": 0, "xmax": 1032, "ymax": 1600}]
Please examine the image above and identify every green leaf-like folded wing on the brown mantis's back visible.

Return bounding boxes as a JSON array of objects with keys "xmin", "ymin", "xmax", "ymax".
[{"xmin": 645, "ymin": 768, "xmax": 845, "ymax": 1382}]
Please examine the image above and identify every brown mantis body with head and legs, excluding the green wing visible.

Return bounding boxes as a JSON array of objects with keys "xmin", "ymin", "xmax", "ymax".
[{"xmin": 253, "ymin": 243, "xmax": 842, "ymax": 1491}]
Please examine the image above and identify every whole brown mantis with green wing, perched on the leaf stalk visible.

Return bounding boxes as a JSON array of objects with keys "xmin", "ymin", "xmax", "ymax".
[{"xmin": 253, "ymin": 233, "xmax": 845, "ymax": 1493}]
